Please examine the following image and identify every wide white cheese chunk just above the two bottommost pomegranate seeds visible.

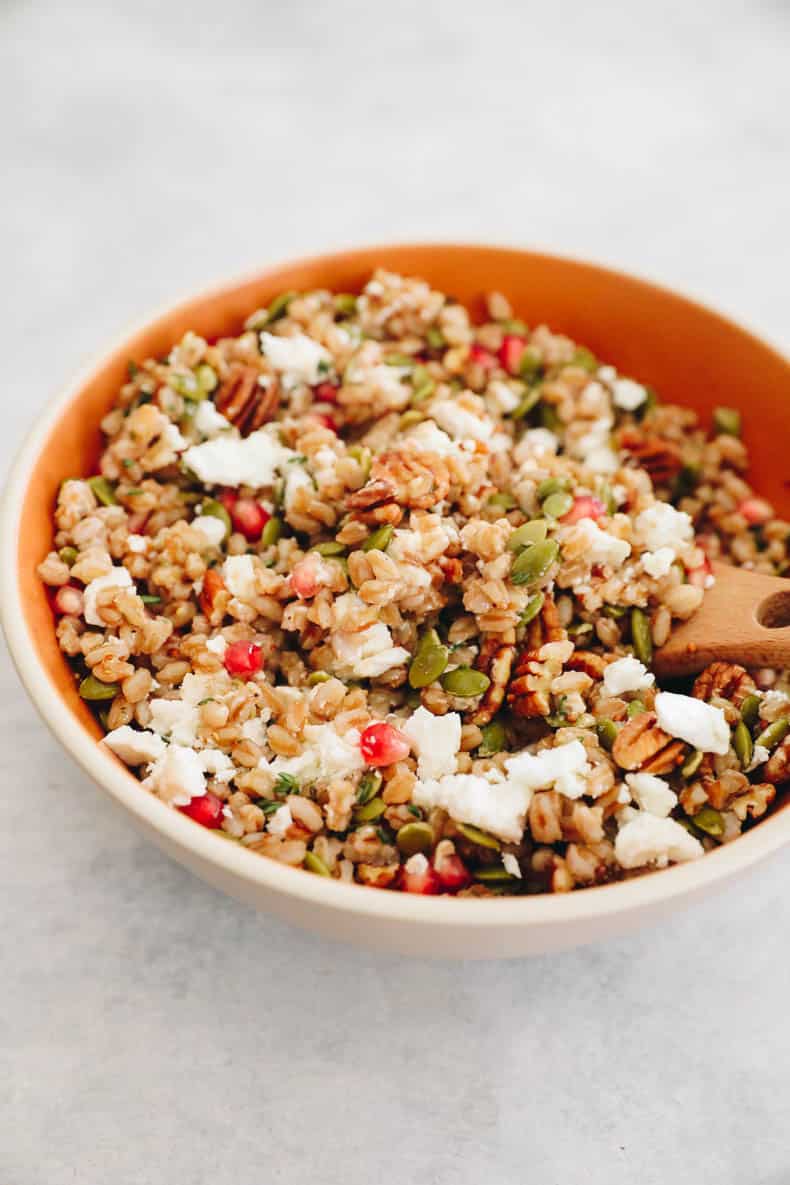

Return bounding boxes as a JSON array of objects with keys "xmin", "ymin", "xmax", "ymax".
[{"xmin": 412, "ymin": 774, "xmax": 531, "ymax": 843}]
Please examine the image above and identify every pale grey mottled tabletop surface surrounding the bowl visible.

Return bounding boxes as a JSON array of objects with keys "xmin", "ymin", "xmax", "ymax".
[{"xmin": 0, "ymin": 0, "xmax": 790, "ymax": 1185}]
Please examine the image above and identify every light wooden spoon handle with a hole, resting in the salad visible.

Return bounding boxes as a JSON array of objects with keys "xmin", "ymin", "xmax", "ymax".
[{"xmin": 653, "ymin": 563, "xmax": 790, "ymax": 677}]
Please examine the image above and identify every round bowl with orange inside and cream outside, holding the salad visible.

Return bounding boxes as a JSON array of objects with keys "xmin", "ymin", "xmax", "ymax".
[{"xmin": 0, "ymin": 244, "xmax": 790, "ymax": 957}]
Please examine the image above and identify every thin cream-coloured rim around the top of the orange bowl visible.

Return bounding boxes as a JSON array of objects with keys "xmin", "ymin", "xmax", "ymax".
[{"xmin": 6, "ymin": 241, "xmax": 790, "ymax": 931}]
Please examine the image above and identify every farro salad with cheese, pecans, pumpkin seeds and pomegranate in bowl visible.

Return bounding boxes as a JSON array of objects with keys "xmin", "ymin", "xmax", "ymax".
[{"xmin": 39, "ymin": 271, "xmax": 790, "ymax": 896}]
